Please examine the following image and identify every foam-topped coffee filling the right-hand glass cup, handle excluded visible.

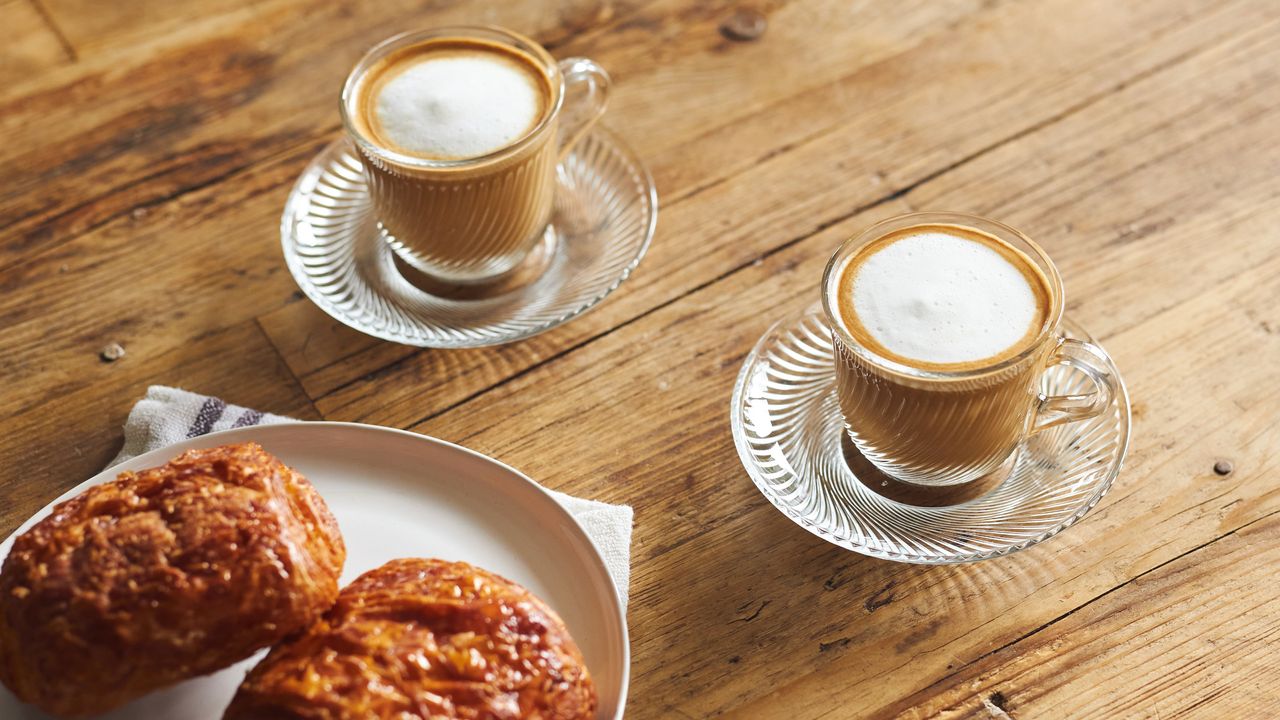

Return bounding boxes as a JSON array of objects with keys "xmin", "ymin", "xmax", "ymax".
[{"xmin": 828, "ymin": 224, "xmax": 1059, "ymax": 484}]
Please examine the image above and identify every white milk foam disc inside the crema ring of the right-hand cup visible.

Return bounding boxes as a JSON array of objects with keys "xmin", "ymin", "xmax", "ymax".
[{"xmin": 845, "ymin": 231, "xmax": 1043, "ymax": 364}]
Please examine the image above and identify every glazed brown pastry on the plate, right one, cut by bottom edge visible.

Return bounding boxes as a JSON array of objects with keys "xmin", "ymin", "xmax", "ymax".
[{"xmin": 224, "ymin": 559, "xmax": 596, "ymax": 720}]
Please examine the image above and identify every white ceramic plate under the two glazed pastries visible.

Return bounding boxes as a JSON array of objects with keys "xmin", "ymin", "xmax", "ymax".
[{"xmin": 0, "ymin": 423, "xmax": 630, "ymax": 720}]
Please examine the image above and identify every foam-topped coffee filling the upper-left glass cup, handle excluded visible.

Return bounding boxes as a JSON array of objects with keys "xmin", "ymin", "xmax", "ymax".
[{"xmin": 343, "ymin": 36, "xmax": 561, "ymax": 283}]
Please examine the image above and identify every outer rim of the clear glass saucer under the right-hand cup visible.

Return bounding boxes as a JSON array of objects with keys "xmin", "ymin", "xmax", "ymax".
[{"xmin": 728, "ymin": 304, "xmax": 1133, "ymax": 565}]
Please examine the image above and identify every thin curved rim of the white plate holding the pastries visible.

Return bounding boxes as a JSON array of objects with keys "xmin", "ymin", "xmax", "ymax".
[{"xmin": 0, "ymin": 420, "xmax": 631, "ymax": 720}]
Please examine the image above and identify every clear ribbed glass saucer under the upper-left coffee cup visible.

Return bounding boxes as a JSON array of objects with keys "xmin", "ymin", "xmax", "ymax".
[{"xmin": 280, "ymin": 128, "xmax": 658, "ymax": 347}]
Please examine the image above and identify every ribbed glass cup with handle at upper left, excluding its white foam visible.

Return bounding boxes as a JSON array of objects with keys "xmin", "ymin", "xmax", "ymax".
[{"xmin": 340, "ymin": 26, "xmax": 609, "ymax": 284}]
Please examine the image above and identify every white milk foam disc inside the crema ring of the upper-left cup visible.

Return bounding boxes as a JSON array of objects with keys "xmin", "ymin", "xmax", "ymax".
[{"xmin": 375, "ymin": 53, "xmax": 541, "ymax": 159}]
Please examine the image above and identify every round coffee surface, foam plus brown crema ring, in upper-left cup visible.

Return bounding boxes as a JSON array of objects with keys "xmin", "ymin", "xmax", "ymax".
[{"xmin": 353, "ymin": 38, "xmax": 553, "ymax": 161}]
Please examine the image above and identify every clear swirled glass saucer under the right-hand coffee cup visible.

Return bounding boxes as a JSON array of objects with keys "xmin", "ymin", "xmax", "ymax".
[{"xmin": 730, "ymin": 305, "xmax": 1129, "ymax": 564}]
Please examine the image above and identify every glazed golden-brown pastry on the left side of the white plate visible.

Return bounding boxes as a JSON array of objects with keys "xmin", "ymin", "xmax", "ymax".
[{"xmin": 0, "ymin": 443, "xmax": 347, "ymax": 716}]
